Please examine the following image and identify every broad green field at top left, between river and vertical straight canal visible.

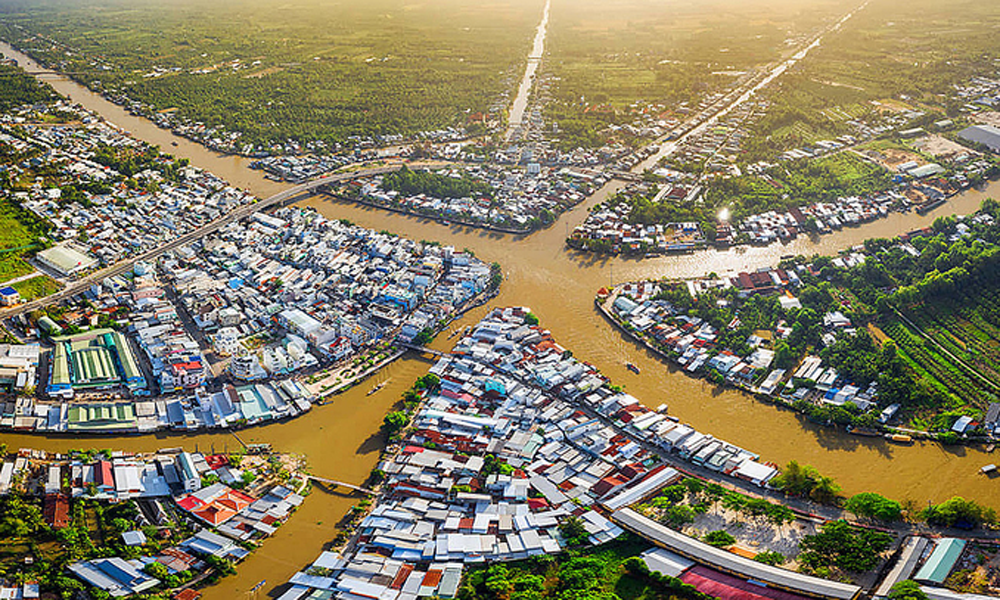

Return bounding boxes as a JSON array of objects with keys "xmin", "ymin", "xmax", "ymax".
[{"xmin": 0, "ymin": 0, "xmax": 543, "ymax": 148}]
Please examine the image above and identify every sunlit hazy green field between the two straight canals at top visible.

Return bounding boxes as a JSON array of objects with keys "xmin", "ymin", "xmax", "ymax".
[{"xmin": 545, "ymin": 0, "xmax": 853, "ymax": 145}]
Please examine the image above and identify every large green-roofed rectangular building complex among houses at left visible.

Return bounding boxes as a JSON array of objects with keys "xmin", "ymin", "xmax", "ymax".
[{"xmin": 46, "ymin": 329, "xmax": 146, "ymax": 398}]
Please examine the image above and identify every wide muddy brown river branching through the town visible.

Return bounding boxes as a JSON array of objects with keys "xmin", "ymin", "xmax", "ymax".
[{"xmin": 0, "ymin": 31, "xmax": 1000, "ymax": 600}]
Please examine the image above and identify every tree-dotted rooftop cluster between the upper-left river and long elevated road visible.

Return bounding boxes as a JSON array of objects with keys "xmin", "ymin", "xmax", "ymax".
[{"xmin": 0, "ymin": 102, "xmax": 255, "ymax": 264}]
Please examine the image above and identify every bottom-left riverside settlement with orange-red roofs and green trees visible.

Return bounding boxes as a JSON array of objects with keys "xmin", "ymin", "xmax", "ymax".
[{"xmin": 0, "ymin": 447, "xmax": 308, "ymax": 597}]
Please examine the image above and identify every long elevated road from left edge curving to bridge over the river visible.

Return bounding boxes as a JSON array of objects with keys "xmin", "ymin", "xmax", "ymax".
[{"xmin": 0, "ymin": 164, "xmax": 403, "ymax": 319}]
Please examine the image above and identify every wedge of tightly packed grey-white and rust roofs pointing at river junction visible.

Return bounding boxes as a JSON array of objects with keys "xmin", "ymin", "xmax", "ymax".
[{"xmin": 283, "ymin": 308, "xmax": 777, "ymax": 599}]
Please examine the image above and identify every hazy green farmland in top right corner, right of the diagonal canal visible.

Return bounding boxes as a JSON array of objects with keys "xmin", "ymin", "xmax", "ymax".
[{"xmin": 744, "ymin": 0, "xmax": 1000, "ymax": 161}]
